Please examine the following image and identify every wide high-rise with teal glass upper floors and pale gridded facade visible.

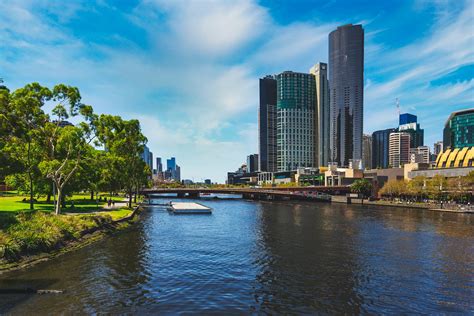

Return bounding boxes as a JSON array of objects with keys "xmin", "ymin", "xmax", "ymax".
[{"xmin": 277, "ymin": 71, "xmax": 316, "ymax": 171}]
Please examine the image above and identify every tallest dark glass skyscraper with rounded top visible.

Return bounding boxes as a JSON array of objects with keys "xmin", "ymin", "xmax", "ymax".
[{"xmin": 329, "ymin": 24, "xmax": 364, "ymax": 166}]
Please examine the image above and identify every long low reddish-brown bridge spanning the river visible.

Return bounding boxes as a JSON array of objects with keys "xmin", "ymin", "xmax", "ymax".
[{"xmin": 140, "ymin": 186, "xmax": 350, "ymax": 201}]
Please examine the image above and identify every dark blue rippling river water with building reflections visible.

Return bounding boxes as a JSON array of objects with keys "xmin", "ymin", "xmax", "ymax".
[{"xmin": 0, "ymin": 200, "xmax": 474, "ymax": 314}]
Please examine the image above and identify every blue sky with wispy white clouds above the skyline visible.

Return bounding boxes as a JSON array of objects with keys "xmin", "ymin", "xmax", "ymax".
[{"xmin": 0, "ymin": 0, "xmax": 474, "ymax": 182}]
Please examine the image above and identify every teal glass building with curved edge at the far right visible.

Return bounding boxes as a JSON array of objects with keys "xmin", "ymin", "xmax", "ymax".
[{"xmin": 443, "ymin": 108, "xmax": 474, "ymax": 149}]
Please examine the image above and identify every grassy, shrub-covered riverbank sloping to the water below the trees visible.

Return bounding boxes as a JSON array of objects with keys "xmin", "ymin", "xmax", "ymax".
[{"xmin": 0, "ymin": 206, "xmax": 140, "ymax": 274}]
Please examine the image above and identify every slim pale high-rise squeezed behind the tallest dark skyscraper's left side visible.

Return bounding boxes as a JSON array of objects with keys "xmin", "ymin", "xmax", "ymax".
[{"xmin": 310, "ymin": 63, "xmax": 330, "ymax": 167}]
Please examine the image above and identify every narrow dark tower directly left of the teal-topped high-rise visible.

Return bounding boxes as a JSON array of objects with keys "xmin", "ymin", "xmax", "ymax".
[{"xmin": 258, "ymin": 76, "xmax": 277, "ymax": 172}]
